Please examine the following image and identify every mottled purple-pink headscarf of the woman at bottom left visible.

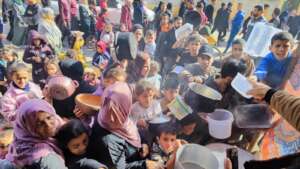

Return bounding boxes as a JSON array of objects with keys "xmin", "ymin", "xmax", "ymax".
[{"xmin": 6, "ymin": 99, "xmax": 63, "ymax": 167}]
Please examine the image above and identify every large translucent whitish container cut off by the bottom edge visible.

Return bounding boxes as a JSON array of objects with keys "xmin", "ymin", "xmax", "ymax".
[{"xmin": 174, "ymin": 144, "xmax": 219, "ymax": 169}]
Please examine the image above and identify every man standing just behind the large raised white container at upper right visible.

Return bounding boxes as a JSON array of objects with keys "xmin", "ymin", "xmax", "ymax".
[{"xmin": 243, "ymin": 5, "xmax": 266, "ymax": 41}]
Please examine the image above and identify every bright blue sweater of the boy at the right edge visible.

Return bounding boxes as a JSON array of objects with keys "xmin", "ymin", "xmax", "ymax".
[{"xmin": 256, "ymin": 53, "xmax": 292, "ymax": 89}]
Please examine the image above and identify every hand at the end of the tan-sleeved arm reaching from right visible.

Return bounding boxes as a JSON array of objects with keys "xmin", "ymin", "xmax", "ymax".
[{"xmin": 247, "ymin": 81, "xmax": 271, "ymax": 100}]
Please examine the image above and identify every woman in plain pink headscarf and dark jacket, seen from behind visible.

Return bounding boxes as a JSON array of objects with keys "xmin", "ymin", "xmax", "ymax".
[{"xmin": 89, "ymin": 82, "xmax": 148, "ymax": 169}]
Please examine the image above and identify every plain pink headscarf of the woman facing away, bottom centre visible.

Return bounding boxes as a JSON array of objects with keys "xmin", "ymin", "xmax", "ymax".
[{"xmin": 98, "ymin": 82, "xmax": 141, "ymax": 147}]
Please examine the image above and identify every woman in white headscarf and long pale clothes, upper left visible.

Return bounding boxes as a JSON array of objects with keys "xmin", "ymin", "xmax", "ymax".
[{"xmin": 38, "ymin": 8, "xmax": 62, "ymax": 54}]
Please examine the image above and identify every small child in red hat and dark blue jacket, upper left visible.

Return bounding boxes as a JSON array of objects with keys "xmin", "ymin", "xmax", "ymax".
[{"xmin": 92, "ymin": 41, "xmax": 113, "ymax": 71}]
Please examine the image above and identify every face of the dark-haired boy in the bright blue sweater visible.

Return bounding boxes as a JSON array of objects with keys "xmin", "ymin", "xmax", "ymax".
[{"xmin": 270, "ymin": 40, "xmax": 292, "ymax": 60}]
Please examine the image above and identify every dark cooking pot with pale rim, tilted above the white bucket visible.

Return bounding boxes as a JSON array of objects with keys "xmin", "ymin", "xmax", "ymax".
[{"xmin": 184, "ymin": 83, "xmax": 222, "ymax": 113}]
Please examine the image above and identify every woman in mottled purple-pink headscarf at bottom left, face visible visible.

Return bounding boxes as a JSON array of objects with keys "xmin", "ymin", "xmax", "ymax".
[{"xmin": 6, "ymin": 99, "xmax": 66, "ymax": 169}]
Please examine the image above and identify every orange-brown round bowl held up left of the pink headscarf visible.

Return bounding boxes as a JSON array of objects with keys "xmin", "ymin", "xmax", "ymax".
[{"xmin": 75, "ymin": 93, "xmax": 101, "ymax": 114}]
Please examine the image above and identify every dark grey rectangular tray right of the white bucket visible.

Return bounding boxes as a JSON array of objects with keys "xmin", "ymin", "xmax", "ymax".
[{"xmin": 234, "ymin": 104, "xmax": 273, "ymax": 128}]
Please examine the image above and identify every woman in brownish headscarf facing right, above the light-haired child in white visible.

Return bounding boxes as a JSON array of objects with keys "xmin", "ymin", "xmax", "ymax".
[{"xmin": 127, "ymin": 53, "xmax": 151, "ymax": 83}]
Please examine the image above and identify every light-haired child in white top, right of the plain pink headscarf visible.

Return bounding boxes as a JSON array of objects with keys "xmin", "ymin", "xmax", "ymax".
[{"xmin": 131, "ymin": 80, "xmax": 161, "ymax": 129}]
